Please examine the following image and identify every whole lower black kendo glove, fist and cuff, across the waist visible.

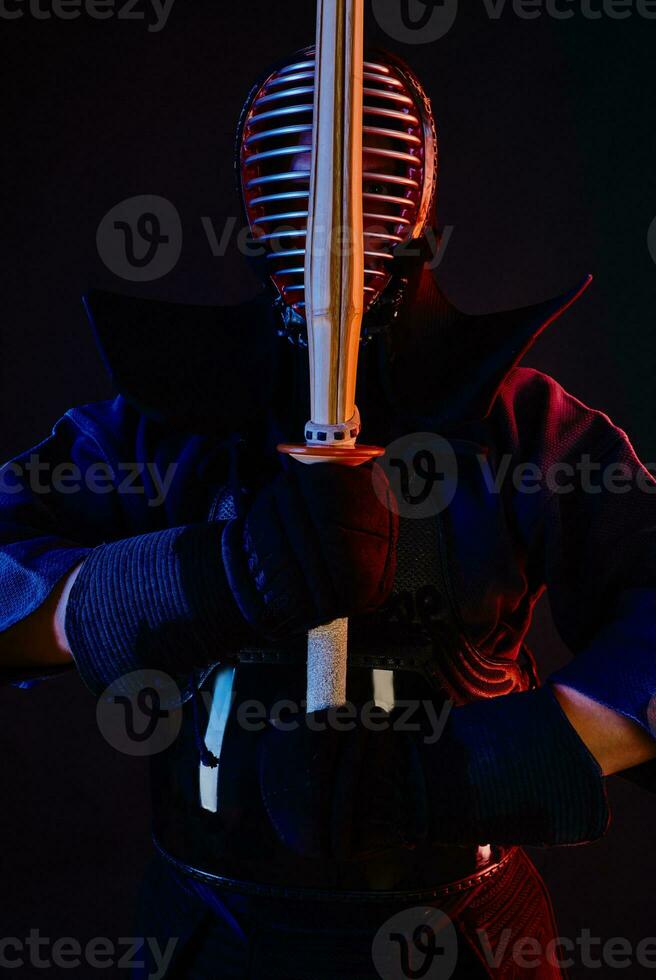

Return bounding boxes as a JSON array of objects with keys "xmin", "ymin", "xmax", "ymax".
[{"xmin": 260, "ymin": 686, "xmax": 609, "ymax": 859}]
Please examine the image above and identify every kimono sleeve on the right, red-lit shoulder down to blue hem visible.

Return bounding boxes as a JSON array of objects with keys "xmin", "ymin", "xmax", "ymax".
[{"xmin": 505, "ymin": 370, "xmax": 656, "ymax": 736}]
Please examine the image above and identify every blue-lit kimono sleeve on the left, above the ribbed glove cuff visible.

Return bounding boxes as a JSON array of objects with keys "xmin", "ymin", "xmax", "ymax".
[{"xmin": 0, "ymin": 397, "xmax": 206, "ymax": 686}]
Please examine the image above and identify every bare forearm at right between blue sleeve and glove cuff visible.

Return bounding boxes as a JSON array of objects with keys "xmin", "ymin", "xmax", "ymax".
[{"xmin": 553, "ymin": 684, "xmax": 656, "ymax": 776}]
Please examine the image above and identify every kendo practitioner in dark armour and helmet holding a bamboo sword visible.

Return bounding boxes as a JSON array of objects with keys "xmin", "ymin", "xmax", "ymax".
[{"xmin": 0, "ymin": 34, "xmax": 656, "ymax": 980}]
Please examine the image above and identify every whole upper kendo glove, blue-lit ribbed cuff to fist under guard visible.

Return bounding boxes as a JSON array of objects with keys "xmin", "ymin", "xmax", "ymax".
[{"xmin": 65, "ymin": 463, "xmax": 397, "ymax": 693}]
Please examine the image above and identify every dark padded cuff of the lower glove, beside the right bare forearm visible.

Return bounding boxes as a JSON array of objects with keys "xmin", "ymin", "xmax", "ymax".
[{"xmin": 424, "ymin": 685, "xmax": 610, "ymax": 845}]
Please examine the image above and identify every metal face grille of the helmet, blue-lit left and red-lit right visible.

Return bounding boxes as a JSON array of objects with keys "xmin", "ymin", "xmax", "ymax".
[{"xmin": 237, "ymin": 48, "xmax": 437, "ymax": 319}]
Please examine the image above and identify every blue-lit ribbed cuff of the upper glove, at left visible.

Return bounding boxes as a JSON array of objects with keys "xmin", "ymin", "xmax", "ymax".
[{"xmin": 65, "ymin": 522, "xmax": 251, "ymax": 694}]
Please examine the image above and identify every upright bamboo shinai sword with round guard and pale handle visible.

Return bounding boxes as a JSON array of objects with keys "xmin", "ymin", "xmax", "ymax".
[{"xmin": 278, "ymin": 0, "xmax": 384, "ymax": 712}]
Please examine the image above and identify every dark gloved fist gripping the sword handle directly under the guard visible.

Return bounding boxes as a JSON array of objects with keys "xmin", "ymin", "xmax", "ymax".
[{"xmin": 223, "ymin": 461, "xmax": 398, "ymax": 639}]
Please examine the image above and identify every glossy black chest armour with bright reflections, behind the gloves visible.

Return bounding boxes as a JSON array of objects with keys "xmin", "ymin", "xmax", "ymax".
[{"xmin": 152, "ymin": 512, "xmax": 531, "ymax": 899}]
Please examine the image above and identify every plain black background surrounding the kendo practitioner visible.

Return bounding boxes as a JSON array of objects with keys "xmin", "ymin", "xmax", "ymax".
[{"xmin": 0, "ymin": 0, "xmax": 656, "ymax": 978}]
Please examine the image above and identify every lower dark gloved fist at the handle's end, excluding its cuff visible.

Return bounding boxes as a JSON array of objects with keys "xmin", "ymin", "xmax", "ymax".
[{"xmin": 258, "ymin": 709, "xmax": 427, "ymax": 859}]
